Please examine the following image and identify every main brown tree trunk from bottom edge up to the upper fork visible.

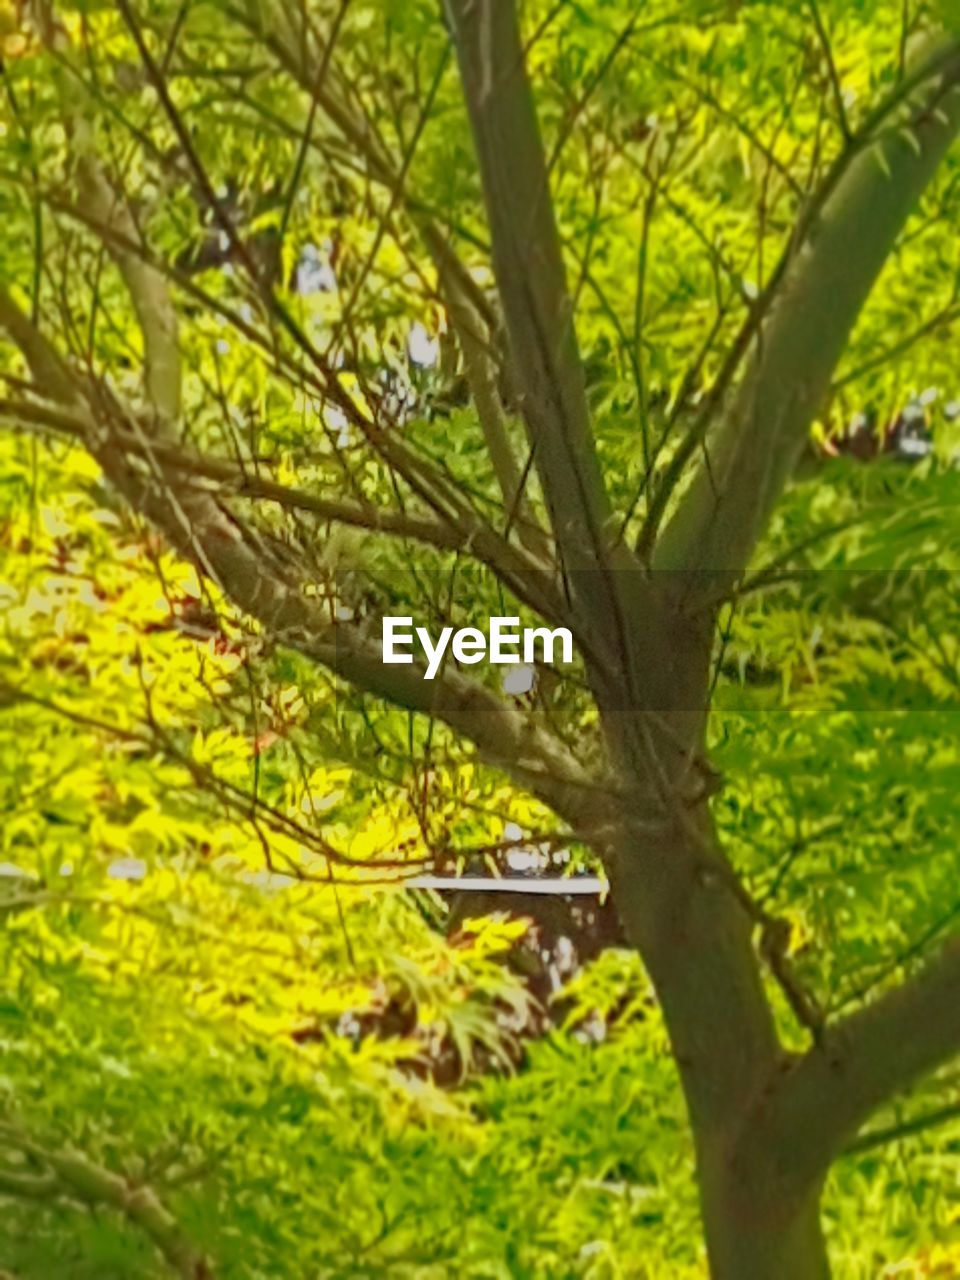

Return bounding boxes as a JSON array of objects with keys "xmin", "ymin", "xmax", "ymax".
[{"xmin": 586, "ymin": 579, "xmax": 829, "ymax": 1280}]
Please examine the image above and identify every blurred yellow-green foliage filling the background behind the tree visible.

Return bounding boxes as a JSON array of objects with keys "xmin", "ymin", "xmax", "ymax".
[{"xmin": 0, "ymin": 0, "xmax": 960, "ymax": 1280}]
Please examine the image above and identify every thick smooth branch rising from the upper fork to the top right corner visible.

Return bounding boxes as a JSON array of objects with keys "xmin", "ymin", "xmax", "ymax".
[{"xmin": 654, "ymin": 41, "xmax": 960, "ymax": 572}]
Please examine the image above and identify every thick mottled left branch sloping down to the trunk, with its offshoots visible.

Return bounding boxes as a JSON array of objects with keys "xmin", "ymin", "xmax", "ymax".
[{"xmin": 0, "ymin": 9, "xmax": 590, "ymax": 810}]
